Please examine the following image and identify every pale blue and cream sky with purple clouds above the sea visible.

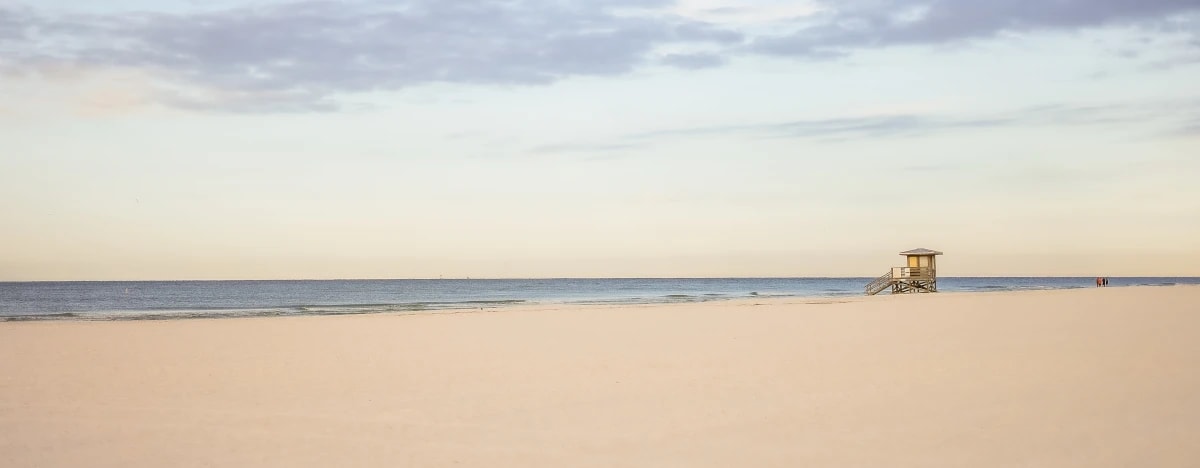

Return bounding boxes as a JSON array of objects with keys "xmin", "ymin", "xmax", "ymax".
[{"xmin": 0, "ymin": 0, "xmax": 1200, "ymax": 281}]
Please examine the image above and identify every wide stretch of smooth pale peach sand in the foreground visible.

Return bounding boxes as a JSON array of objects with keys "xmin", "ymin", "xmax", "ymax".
[{"xmin": 0, "ymin": 287, "xmax": 1200, "ymax": 468}]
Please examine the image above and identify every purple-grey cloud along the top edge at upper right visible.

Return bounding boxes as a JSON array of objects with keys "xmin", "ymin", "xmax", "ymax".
[{"xmin": 750, "ymin": 0, "xmax": 1200, "ymax": 58}]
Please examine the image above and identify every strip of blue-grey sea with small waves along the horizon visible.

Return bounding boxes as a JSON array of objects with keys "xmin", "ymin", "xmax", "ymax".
[{"xmin": 0, "ymin": 277, "xmax": 1200, "ymax": 320}]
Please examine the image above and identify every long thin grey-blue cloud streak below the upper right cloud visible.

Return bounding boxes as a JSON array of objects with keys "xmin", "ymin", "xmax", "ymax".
[{"xmin": 530, "ymin": 100, "xmax": 1200, "ymax": 154}]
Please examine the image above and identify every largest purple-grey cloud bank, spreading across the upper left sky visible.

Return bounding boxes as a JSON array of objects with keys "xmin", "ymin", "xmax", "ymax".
[{"xmin": 0, "ymin": 0, "xmax": 742, "ymax": 110}]
